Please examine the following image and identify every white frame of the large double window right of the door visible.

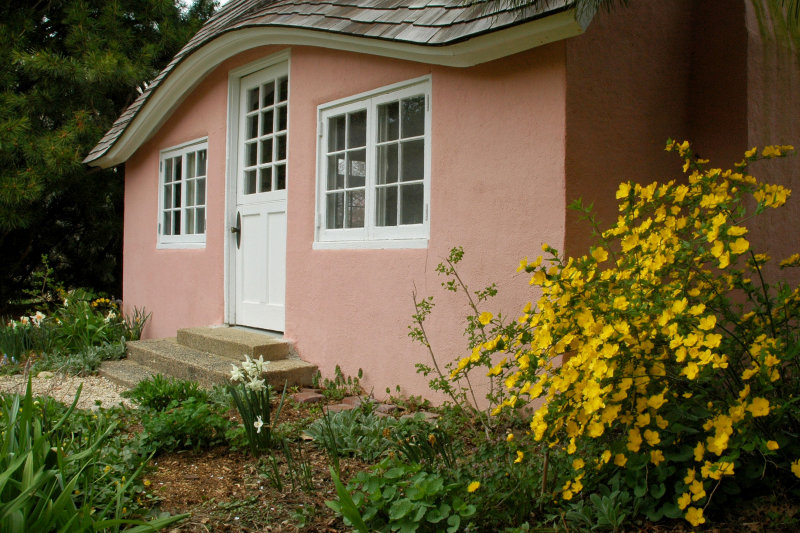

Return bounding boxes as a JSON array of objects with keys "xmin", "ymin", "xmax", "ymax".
[{"xmin": 313, "ymin": 76, "xmax": 431, "ymax": 249}]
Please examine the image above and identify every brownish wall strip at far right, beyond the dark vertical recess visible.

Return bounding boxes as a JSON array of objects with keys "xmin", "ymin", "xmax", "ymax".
[{"xmin": 746, "ymin": 2, "xmax": 800, "ymax": 284}]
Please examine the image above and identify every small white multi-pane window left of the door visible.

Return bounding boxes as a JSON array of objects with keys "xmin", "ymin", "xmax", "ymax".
[{"xmin": 158, "ymin": 140, "xmax": 208, "ymax": 245}]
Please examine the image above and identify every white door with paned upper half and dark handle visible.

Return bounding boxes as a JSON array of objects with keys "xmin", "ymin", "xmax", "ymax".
[{"xmin": 231, "ymin": 64, "xmax": 289, "ymax": 331}]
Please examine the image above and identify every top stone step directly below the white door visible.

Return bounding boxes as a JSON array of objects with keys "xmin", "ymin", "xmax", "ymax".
[{"xmin": 177, "ymin": 326, "xmax": 291, "ymax": 361}]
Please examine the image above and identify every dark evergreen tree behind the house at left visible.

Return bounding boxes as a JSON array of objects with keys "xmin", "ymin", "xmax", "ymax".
[{"xmin": 0, "ymin": 0, "xmax": 218, "ymax": 314}]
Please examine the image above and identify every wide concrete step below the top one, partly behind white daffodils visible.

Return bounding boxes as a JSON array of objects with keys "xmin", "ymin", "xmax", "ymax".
[{"xmin": 123, "ymin": 338, "xmax": 317, "ymax": 388}]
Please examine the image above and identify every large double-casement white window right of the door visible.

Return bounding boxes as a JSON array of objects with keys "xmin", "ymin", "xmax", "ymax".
[{"xmin": 317, "ymin": 80, "xmax": 430, "ymax": 246}]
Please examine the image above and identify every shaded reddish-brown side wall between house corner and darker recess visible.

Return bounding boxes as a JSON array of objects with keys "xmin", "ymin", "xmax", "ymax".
[{"xmin": 566, "ymin": 0, "xmax": 691, "ymax": 255}]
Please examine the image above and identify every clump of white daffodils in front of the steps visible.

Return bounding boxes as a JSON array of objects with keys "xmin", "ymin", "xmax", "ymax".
[{"xmin": 228, "ymin": 356, "xmax": 286, "ymax": 455}]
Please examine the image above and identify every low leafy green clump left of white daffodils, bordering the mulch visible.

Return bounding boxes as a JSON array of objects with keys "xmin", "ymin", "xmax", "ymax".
[{"xmin": 142, "ymin": 396, "xmax": 231, "ymax": 453}]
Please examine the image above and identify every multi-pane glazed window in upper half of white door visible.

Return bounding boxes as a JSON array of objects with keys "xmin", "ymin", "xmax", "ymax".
[{"xmin": 242, "ymin": 76, "xmax": 289, "ymax": 195}]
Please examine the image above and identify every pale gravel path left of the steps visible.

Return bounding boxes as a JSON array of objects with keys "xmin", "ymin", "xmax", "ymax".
[{"xmin": 0, "ymin": 372, "xmax": 131, "ymax": 409}]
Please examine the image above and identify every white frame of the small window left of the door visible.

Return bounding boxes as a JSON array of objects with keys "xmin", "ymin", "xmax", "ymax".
[{"xmin": 156, "ymin": 137, "xmax": 208, "ymax": 248}]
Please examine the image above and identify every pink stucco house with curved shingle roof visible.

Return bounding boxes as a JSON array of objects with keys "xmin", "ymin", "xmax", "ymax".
[{"xmin": 86, "ymin": 0, "xmax": 800, "ymax": 400}]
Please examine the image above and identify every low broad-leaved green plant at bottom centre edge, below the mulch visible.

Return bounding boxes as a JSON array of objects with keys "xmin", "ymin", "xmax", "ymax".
[{"xmin": 327, "ymin": 457, "xmax": 476, "ymax": 532}]
